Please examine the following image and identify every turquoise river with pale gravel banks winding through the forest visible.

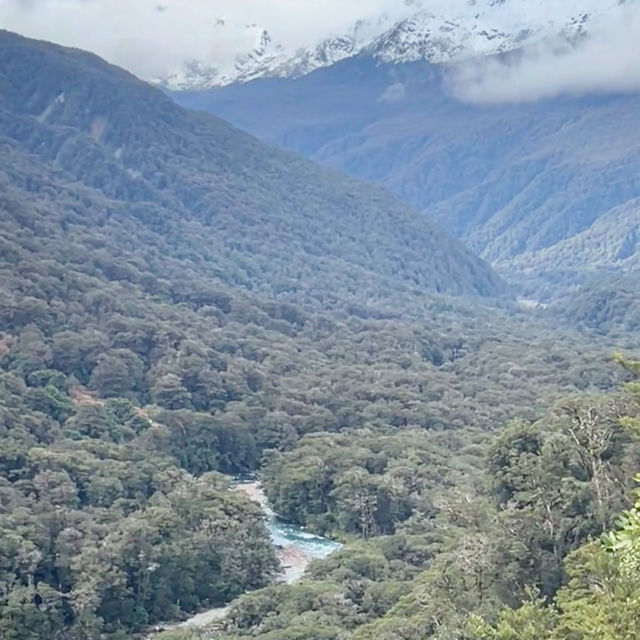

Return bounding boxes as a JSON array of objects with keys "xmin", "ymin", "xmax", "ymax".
[{"xmin": 170, "ymin": 480, "xmax": 341, "ymax": 629}]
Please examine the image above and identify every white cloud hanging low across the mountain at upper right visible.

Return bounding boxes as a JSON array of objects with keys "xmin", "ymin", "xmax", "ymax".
[{"xmin": 450, "ymin": 6, "xmax": 640, "ymax": 104}]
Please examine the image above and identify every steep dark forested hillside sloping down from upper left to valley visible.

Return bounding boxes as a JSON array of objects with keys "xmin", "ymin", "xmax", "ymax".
[{"xmin": 0, "ymin": 32, "xmax": 504, "ymax": 310}]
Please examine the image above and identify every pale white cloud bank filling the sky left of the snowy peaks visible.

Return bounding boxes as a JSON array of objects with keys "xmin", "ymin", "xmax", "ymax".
[{"xmin": 0, "ymin": 0, "xmax": 401, "ymax": 78}]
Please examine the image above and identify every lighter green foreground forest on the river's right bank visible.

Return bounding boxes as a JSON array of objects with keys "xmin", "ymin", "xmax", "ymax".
[{"xmin": 161, "ymin": 361, "xmax": 640, "ymax": 640}]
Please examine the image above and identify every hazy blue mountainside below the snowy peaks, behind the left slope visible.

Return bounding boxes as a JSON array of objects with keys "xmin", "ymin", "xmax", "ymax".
[{"xmin": 176, "ymin": 57, "xmax": 640, "ymax": 294}]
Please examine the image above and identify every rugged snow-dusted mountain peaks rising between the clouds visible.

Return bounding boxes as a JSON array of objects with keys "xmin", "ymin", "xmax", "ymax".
[{"xmin": 157, "ymin": 0, "xmax": 640, "ymax": 90}]
